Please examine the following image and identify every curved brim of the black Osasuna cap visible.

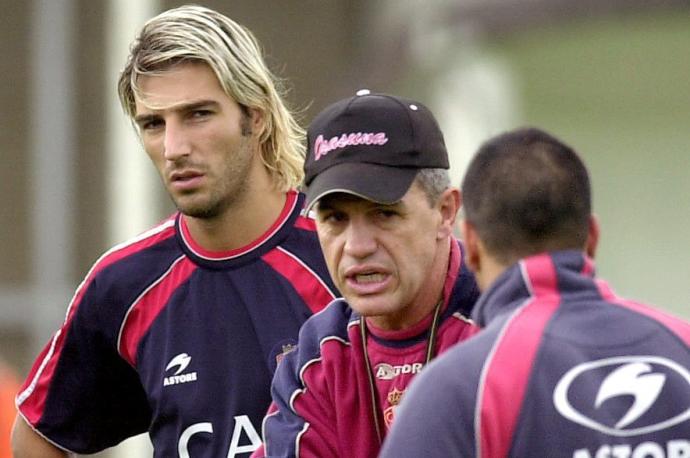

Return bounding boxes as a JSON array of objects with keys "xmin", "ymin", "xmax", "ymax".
[{"xmin": 305, "ymin": 162, "xmax": 419, "ymax": 211}]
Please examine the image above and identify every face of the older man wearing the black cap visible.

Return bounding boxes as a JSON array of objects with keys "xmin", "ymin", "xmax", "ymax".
[{"xmin": 316, "ymin": 183, "xmax": 448, "ymax": 329}]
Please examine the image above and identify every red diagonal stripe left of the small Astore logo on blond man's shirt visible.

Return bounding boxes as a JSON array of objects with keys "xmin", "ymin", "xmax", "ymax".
[{"xmin": 117, "ymin": 255, "xmax": 197, "ymax": 366}]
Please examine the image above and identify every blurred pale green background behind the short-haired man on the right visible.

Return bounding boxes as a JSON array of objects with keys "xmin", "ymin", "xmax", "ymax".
[{"xmin": 490, "ymin": 10, "xmax": 690, "ymax": 318}]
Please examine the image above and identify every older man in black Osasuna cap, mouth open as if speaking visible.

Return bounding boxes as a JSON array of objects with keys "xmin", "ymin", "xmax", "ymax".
[{"xmin": 255, "ymin": 92, "xmax": 478, "ymax": 458}]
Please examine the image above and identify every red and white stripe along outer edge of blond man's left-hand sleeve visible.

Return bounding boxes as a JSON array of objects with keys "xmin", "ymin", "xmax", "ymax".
[{"xmin": 16, "ymin": 218, "xmax": 175, "ymax": 425}]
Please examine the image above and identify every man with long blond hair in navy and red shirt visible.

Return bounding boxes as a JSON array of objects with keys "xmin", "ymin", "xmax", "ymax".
[{"xmin": 13, "ymin": 6, "xmax": 336, "ymax": 458}]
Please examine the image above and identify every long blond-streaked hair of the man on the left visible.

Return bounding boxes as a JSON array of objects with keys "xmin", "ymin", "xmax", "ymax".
[{"xmin": 118, "ymin": 5, "xmax": 305, "ymax": 190}]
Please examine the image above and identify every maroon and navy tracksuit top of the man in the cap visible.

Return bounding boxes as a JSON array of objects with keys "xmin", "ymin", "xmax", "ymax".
[{"xmin": 252, "ymin": 241, "xmax": 479, "ymax": 458}]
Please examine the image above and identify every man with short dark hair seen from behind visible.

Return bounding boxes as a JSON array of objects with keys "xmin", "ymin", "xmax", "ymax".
[{"xmin": 381, "ymin": 129, "xmax": 690, "ymax": 458}]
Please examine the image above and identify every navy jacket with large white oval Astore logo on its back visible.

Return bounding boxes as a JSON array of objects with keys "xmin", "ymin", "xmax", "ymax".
[{"xmin": 381, "ymin": 251, "xmax": 690, "ymax": 458}]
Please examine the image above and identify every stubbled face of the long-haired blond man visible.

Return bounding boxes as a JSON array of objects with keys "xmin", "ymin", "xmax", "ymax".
[{"xmin": 134, "ymin": 63, "xmax": 260, "ymax": 218}]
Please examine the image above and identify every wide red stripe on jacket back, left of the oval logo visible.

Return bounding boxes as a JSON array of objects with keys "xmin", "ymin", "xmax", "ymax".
[{"xmin": 475, "ymin": 255, "xmax": 560, "ymax": 458}]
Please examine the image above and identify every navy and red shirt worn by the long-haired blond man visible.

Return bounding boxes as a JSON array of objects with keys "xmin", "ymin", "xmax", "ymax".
[{"xmin": 16, "ymin": 191, "xmax": 336, "ymax": 457}]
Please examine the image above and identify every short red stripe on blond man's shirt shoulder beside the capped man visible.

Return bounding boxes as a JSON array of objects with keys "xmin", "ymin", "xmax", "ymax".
[{"xmin": 262, "ymin": 247, "xmax": 335, "ymax": 313}]
